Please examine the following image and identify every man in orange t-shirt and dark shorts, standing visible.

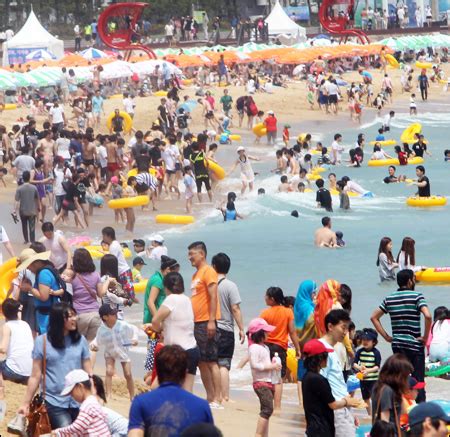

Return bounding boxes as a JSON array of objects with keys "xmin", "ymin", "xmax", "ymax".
[{"xmin": 188, "ymin": 241, "xmax": 223, "ymax": 409}]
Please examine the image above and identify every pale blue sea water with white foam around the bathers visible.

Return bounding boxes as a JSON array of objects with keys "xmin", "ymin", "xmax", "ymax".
[{"xmin": 125, "ymin": 113, "xmax": 450, "ymax": 388}]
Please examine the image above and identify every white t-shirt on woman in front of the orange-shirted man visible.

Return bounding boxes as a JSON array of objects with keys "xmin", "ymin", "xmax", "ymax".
[{"xmin": 162, "ymin": 294, "xmax": 197, "ymax": 350}]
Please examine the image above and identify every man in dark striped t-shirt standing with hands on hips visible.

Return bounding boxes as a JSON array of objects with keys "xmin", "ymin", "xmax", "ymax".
[{"xmin": 370, "ymin": 270, "xmax": 431, "ymax": 402}]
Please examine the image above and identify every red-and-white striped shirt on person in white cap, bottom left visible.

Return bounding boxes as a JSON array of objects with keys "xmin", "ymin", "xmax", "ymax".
[{"xmin": 54, "ymin": 395, "xmax": 111, "ymax": 437}]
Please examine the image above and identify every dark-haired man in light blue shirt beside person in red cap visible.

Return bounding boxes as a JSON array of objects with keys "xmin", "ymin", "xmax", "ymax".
[{"xmin": 319, "ymin": 310, "xmax": 357, "ymax": 437}]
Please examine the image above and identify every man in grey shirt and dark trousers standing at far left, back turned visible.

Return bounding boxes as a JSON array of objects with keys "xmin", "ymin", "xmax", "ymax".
[{"xmin": 13, "ymin": 171, "xmax": 41, "ymax": 244}]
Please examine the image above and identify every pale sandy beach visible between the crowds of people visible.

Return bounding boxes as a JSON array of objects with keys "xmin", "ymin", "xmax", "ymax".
[{"xmin": 0, "ymin": 64, "xmax": 450, "ymax": 437}]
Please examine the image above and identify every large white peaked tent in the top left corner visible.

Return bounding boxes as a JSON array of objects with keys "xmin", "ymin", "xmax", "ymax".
[{"xmin": 3, "ymin": 11, "xmax": 64, "ymax": 66}]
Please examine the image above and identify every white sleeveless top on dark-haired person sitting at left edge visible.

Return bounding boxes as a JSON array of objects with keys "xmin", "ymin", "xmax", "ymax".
[{"xmin": 6, "ymin": 320, "xmax": 34, "ymax": 376}]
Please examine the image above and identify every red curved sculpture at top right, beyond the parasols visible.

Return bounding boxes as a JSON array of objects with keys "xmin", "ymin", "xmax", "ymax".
[{"xmin": 319, "ymin": 0, "xmax": 370, "ymax": 44}]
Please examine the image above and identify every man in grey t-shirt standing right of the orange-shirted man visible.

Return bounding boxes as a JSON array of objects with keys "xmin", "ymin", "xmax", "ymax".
[{"xmin": 211, "ymin": 253, "xmax": 245, "ymax": 402}]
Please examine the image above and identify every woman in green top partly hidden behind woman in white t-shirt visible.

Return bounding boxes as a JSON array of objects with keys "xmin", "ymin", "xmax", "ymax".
[{"xmin": 144, "ymin": 255, "xmax": 180, "ymax": 385}]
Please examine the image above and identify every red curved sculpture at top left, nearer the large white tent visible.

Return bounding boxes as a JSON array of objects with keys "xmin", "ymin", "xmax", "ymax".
[{"xmin": 97, "ymin": 3, "xmax": 156, "ymax": 59}]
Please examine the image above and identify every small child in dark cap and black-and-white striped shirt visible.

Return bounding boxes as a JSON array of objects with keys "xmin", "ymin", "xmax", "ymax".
[{"xmin": 353, "ymin": 328, "xmax": 381, "ymax": 415}]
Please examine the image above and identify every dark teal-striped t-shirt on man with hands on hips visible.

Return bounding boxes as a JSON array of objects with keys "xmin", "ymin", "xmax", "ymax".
[{"xmin": 380, "ymin": 290, "xmax": 427, "ymax": 352}]
